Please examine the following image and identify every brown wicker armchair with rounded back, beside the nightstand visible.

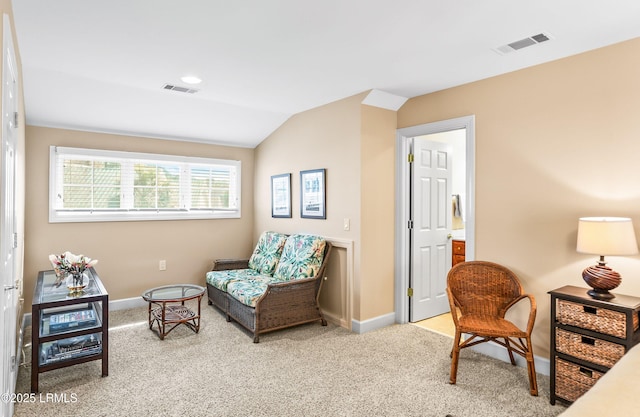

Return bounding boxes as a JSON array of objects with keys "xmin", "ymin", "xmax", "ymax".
[{"xmin": 447, "ymin": 261, "xmax": 538, "ymax": 395}]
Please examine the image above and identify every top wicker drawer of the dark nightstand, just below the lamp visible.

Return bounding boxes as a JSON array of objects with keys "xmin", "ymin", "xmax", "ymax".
[{"xmin": 556, "ymin": 300, "xmax": 638, "ymax": 339}]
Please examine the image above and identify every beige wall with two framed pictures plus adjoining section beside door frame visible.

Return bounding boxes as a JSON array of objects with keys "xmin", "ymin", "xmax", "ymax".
[{"xmin": 254, "ymin": 93, "xmax": 397, "ymax": 325}]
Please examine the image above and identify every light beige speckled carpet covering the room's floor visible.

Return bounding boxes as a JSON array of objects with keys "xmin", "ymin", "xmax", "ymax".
[{"xmin": 15, "ymin": 301, "xmax": 564, "ymax": 417}]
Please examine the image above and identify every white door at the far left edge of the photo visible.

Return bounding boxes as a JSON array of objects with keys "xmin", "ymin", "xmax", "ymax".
[{"xmin": 0, "ymin": 15, "xmax": 18, "ymax": 416}]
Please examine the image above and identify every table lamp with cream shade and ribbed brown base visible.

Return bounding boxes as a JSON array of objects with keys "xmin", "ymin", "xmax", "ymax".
[{"xmin": 576, "ymin": 217, "xmax": 638, "ymax": 300}]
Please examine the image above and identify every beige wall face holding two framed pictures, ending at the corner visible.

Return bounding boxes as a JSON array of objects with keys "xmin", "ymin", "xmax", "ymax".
[{"xmin": 254, "ymin": 94, "xmax": 366, "ymax": 321}]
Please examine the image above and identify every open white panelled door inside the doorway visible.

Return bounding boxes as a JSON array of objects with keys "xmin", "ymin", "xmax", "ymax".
[{"xmin": 409, "ymin": 138, "xmax": 452, "ymax": 322}]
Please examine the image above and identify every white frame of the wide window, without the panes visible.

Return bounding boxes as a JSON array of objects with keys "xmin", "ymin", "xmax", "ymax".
[{"xmin": 49, "ymin": 146, "xmax": 242, "ymax": 223}]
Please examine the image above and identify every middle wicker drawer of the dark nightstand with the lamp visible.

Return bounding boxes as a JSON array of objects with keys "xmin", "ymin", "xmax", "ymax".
[{"xmin": 556, "ymin": 329, "xmax": 624, "ymax": 368}]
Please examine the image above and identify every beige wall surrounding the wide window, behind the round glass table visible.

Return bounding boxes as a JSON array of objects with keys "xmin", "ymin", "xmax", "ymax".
[{"xmin": 25, "ymin": 126, "xmax": 254, "ymax": 303}]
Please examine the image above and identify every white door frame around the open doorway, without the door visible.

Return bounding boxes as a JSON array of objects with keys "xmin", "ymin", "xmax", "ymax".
[{"xmin": 394, "ymin": 115, "xmax": 476, "ymax": 323}]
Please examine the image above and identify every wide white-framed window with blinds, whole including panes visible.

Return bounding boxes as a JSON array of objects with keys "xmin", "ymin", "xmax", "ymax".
[{"xmin": 49, "ymin": 146, "xmax": 240, "ymax": 223}]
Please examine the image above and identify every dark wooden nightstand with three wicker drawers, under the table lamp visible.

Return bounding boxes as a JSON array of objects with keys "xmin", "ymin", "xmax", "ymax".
[{"xmin": 549, "ymin": 285, "xmax": 640, "ymax": 404}]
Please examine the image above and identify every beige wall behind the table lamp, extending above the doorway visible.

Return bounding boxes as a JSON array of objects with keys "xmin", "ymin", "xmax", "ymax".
[{"xmin": 398, "ymin": 39, "xmax": 640, "ymax": 356}]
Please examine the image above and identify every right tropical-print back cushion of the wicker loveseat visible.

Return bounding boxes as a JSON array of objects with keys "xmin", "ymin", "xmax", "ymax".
[{"xmin": 273, "ymin": 235, "xmax": 326, "ymax": 281}]
